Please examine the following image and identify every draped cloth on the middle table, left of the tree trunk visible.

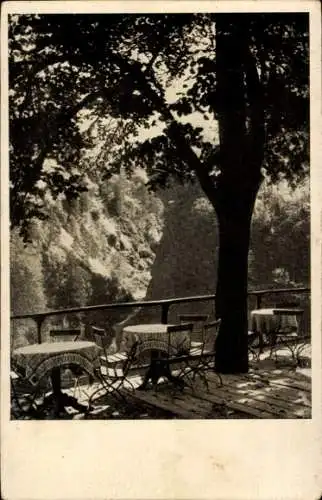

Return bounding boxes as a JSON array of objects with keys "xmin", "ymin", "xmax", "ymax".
[{"xmin": 123, "ymin": 323, "xmax": 191, "ymax": 355}]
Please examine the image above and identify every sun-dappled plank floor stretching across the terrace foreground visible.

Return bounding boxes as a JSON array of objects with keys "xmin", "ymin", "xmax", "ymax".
[{"xmin": 12, "ymin": 342, "xmax": 311, "ymax": 420}]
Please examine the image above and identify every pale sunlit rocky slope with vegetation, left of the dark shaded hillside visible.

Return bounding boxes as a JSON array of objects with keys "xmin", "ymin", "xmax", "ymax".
[{"xmin": 10, "ymin": 171, "xmax": 162, "ymax": 348}]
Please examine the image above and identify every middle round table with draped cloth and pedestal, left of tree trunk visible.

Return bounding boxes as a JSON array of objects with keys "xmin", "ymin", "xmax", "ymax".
[{"xmin": 123, "ymin": 323, "xmax": 190, "ymax": 390}]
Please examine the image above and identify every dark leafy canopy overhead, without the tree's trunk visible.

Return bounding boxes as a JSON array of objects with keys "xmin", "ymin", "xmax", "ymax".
[{"xmin": 9, "ymin": 14, "xmax": 309, "ymax": 230}]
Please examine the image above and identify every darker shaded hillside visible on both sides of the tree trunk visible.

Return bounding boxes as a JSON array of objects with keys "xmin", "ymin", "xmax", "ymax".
[{"xmin": 142, "ymin": 179, "xmax": 310, "ymax": 310}]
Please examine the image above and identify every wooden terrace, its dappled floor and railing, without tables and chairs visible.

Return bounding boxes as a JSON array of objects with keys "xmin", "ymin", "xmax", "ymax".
[{"xmin": 11, "ymin": 288, "xmax": 311, "ymax": 420}]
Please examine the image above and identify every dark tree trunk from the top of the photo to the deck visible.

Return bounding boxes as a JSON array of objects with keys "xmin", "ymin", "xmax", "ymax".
[{"xmin": 213, "ymin": 15, "xmax": 263, "ymax": 373}]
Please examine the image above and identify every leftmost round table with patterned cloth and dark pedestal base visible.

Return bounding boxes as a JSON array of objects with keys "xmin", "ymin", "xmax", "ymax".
[{"xmin": 12, "ymin": 341, "xmax": 101, "ymax": 416}]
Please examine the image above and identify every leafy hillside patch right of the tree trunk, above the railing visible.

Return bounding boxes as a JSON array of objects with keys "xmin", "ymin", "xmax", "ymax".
[{"xmin": 249, "ymin": 181, "xmax": 310, "ymax": 287}]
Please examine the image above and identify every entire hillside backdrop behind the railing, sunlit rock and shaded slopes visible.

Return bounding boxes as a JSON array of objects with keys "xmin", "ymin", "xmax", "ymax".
[{"xmin": 11, "ymin": 174, "xmax": 310, "ymax": 345}]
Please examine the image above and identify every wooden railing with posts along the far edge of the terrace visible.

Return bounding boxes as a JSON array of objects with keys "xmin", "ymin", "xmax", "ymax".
[{"xmin": 10, "ymin": 287, "xmax": 310, "ymax": 343}]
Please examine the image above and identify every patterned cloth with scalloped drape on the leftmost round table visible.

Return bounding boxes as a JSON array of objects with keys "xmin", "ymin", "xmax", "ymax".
[{"xmin": 12, "ymin": 341, "xmax": 102, "ymax": 384}]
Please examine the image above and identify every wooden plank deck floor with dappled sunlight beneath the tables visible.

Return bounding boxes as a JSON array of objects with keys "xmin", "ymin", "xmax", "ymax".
[{"xmin": 65, "ymin": 344, "xmax": 311, "ymax": 419}]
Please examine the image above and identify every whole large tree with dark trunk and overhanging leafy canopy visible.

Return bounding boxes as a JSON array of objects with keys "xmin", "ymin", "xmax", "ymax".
[{"xmin": 9, "ymin": 13, "xmax": 309, "ymax": 373}]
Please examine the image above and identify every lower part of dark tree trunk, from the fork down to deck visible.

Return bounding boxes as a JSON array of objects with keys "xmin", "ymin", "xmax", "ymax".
[{"xmin": 215, "ymin": 186, "xmax": 258, "ymax": 373}]
